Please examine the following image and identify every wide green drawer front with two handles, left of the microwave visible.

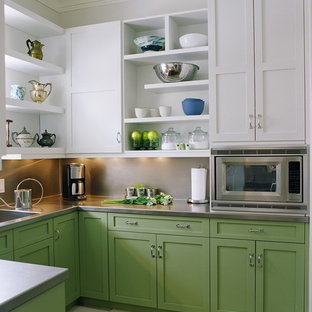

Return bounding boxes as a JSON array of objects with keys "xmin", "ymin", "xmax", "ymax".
[{"xmin": 108, "ymin": 213, "xmax": 209, "ymax": 237}]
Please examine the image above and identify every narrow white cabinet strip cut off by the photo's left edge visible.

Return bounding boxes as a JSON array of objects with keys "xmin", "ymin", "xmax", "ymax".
[{"xmin": 0, "ymin": 0, "xmax": 6, "ymax": 158}]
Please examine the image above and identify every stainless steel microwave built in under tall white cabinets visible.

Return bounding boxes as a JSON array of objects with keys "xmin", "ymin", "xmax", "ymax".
[{"xmin": 211, "ymin": 148, "xmax": 308, "ymax": 212}]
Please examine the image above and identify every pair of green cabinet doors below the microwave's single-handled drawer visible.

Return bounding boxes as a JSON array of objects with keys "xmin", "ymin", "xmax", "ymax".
[{"xmin": 210, "ymin": 238, "xmax": 304, "ymax": 312}]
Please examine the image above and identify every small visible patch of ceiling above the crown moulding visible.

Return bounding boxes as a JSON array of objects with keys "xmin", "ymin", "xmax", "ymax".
[{"xmin": 38, "ymin": 0, "xmax": 128, "ymax": 13}]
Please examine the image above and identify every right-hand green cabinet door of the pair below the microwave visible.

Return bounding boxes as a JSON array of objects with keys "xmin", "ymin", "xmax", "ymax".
[{"xmin": 256, "ymin": 242, "xmax": 304, "ymax": 312}]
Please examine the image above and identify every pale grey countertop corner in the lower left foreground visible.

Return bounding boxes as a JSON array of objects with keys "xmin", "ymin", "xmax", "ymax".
[{"xmin": 0, "ymin": 260, "xmax": 68, "ymax": 312}]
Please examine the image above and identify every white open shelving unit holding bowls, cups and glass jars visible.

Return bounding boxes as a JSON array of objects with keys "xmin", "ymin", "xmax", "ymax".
[{"xmin": 123, "ymin": 9, "xmax": 210, "ymax": 157}]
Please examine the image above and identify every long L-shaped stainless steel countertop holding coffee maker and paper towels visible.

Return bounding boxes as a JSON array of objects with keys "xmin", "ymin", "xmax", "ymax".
[{"xmin": 0, "ymin": 195, "xmax": 309, "ymax": 230}]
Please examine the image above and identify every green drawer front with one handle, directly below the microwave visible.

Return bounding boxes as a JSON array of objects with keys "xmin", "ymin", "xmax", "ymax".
[{"xmin": 210, "ymin": 219, "xmax": 304, "ymax": 243}]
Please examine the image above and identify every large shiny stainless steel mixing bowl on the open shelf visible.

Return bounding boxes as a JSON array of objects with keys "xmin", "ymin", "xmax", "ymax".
[{"xmin": 153, "ymin": 62, "xmax": 199, "ymax": 82}]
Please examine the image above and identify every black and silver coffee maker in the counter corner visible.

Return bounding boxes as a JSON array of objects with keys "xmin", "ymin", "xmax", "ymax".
[{"xmin": 63, "ymin": 163, "xmax": 86, "ymax": 200}]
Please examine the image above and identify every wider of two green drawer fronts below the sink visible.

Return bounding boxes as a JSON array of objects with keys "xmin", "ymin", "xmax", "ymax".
[{"xmin": 13, "ymin": 219, "xmax": 53, "ymax": 249}]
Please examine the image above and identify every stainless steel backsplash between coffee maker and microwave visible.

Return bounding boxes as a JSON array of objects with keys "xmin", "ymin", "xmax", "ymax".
[{"xmin": 62, "ymin": 158, "xmax": 209, "ymax": 199}]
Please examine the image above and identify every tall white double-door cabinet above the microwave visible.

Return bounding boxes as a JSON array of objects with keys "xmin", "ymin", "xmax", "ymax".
[{"xmin": 208, "ymin": 0, "xmax": 305, "ymax": 144}]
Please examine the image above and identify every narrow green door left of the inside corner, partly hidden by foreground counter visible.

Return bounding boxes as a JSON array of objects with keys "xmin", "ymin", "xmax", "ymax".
[{"xmin": 53, "ymin": 212, "xmax": 80, "ymax": 304}]
